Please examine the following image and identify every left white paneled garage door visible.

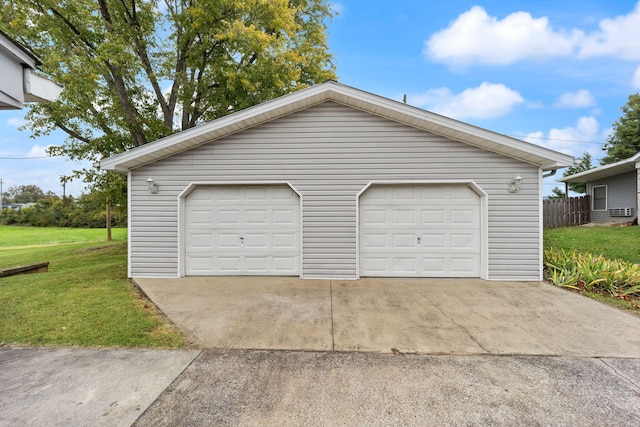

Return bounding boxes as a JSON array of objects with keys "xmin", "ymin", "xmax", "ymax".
[{"xmin": 185, "ymin": 185, "xmax": 300, "ymax": 276}]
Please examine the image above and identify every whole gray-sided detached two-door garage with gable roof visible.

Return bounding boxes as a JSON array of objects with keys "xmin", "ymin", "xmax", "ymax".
[{"xmin": 100, "ymin": 81, "xmax": 573, "ymax": 280}]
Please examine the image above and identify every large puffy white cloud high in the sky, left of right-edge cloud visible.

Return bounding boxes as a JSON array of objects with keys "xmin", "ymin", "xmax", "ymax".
[{"xmin": 424, "ymin": 6, "xmax": 580, "ymax": 65}]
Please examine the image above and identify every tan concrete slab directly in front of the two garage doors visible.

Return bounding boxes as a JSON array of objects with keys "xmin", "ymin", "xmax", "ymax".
[{"xmin": 135, "ymin": 277, "xmax": 640, "ymax": 358}]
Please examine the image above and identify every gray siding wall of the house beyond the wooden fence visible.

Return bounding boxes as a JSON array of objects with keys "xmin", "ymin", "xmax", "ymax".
[{"xmin": 587, "ymin": 170, "xmax": 638, "ymax": 222}]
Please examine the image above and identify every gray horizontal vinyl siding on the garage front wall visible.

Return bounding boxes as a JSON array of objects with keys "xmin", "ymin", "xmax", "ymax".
[{"xmin": 130, "ymin": 102, "xmax": 541, "ymax": 280}]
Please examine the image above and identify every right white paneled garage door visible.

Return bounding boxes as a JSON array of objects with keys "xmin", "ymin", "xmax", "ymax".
[{"xmin": 360, "ymin": 185, "xmax": 481, "ymax": 277}]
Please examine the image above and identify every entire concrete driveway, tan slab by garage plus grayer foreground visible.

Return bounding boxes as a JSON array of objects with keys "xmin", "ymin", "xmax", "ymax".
[{"xmin": 0, "ymin": 278, "xmax": 640, "ymax": 427}]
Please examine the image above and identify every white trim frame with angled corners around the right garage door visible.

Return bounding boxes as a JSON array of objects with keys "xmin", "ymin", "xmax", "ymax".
[{"xmin": 354, "ymin": 179, "xmax": 489, "ymax": 280}]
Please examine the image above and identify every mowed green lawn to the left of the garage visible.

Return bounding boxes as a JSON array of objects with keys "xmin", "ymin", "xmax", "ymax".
[{"xmin": 0, "ymin": 226, "xmax": 184, "ymax": 348}]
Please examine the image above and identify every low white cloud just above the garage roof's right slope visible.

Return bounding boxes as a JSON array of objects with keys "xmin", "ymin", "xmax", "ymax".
[{"xmin": 408, "ymin": 82, "xmax": 524, "ymax": 119}]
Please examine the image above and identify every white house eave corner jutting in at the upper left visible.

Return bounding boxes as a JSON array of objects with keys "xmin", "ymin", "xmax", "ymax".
[{"xmin": 0, "ymin": 31, "xmax": 62, "ymax": 110}]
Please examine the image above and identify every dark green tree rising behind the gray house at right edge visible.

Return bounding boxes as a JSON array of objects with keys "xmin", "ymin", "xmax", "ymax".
[{"xmin": 600, "ymin": 93, "xmax": 640, "ymax": 165}]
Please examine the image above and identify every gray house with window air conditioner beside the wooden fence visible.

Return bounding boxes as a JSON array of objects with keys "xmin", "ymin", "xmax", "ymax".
[{"xmin": 558, "ymin": 153, "xmax": 640, "ymax": 223}]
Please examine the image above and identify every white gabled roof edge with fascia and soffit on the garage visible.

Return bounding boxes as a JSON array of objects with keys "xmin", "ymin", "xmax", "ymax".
[{"xmin": 100, "ymin": 81, "xmax": 573, "ymax": 172}]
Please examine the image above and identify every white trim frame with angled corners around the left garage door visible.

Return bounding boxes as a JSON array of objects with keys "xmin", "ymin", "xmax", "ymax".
[{"xmin": 177, "ymin": 181, "xmax": 304, "ymax": 279}]
